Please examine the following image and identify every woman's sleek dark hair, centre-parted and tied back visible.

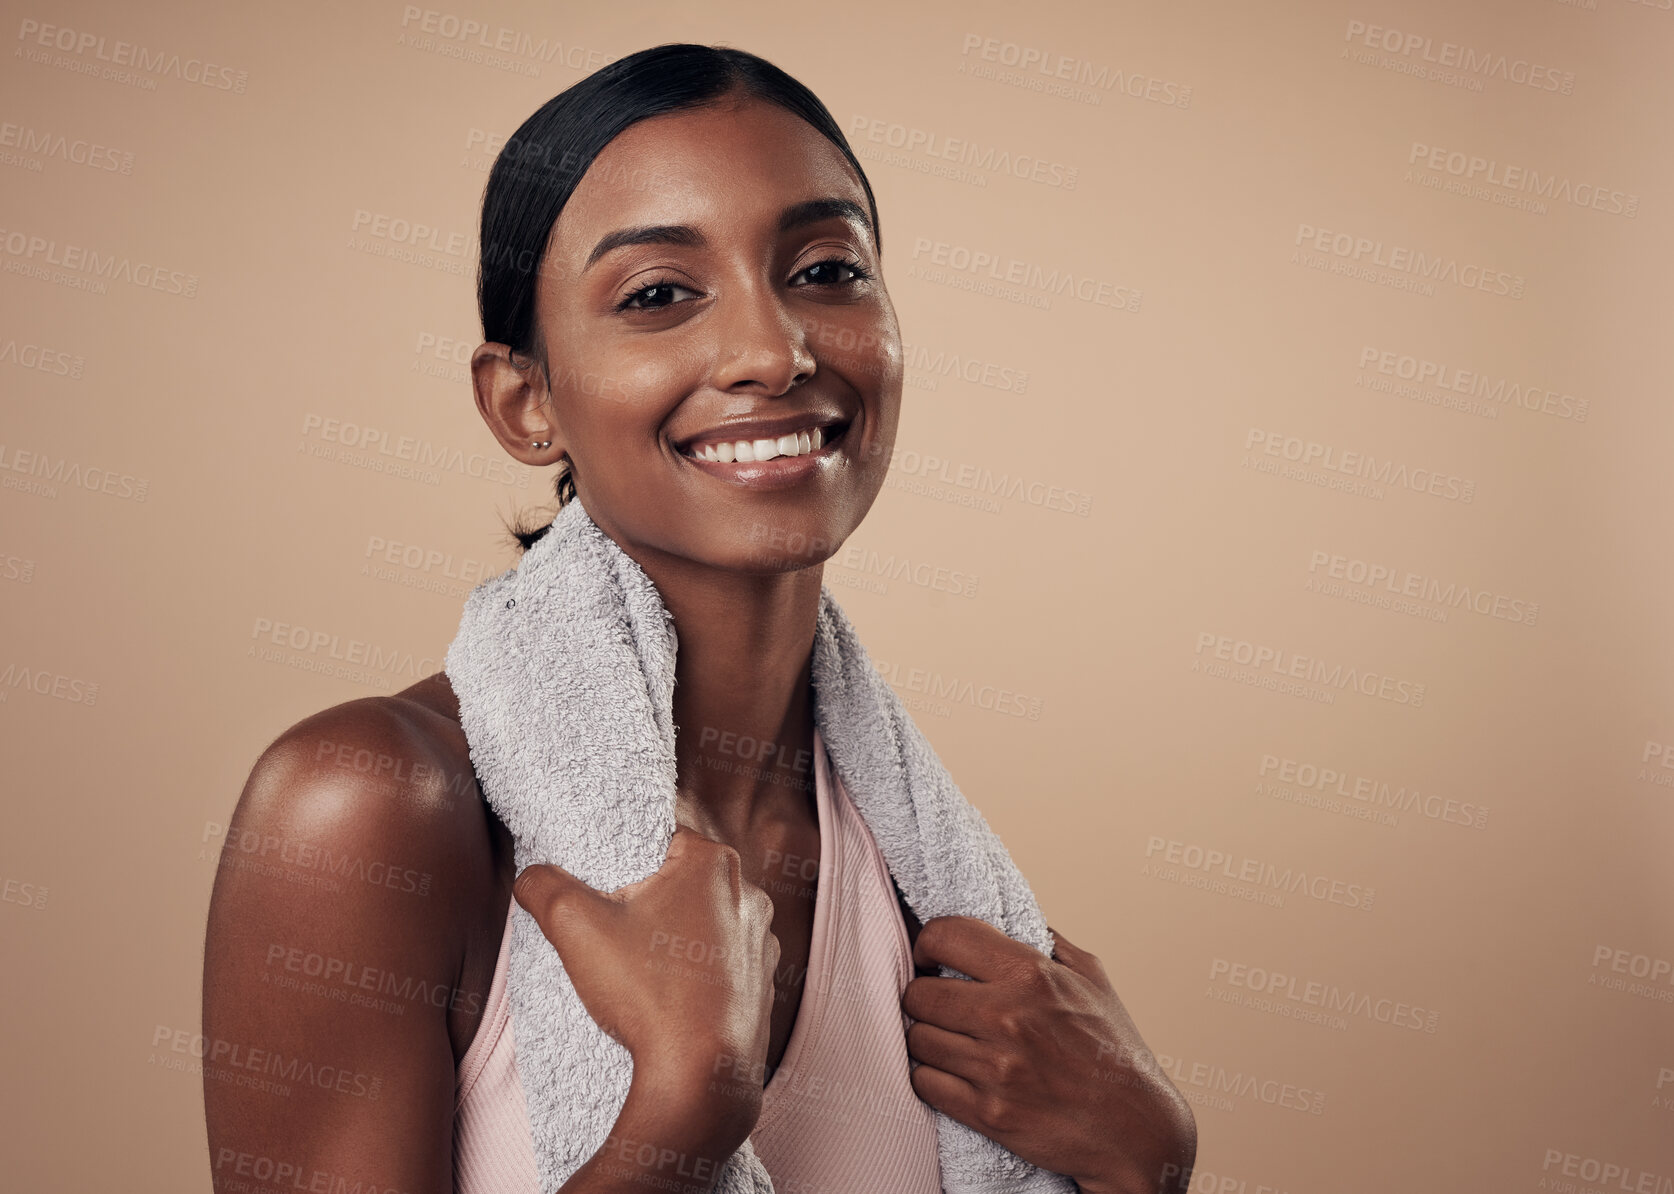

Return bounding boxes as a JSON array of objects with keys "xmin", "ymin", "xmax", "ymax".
[{"xmin": 477, "ymin": 42, "xmax": 882, "ymax": 551}]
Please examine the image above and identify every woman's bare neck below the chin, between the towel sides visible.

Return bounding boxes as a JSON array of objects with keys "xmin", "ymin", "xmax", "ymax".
[{"xmin": 641, "ymin": 545, "xmax": 824, "ymax": 841}]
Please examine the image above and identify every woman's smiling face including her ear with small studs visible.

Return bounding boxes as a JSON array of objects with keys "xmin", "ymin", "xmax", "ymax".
[{"xmin": 477, "ymin": 97, "xmax": 901, "ymax": 573}]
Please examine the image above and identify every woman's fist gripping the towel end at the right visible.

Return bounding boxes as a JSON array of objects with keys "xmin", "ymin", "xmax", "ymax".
[{"xmin": 901, "ymin": 916, "xmax": 1197, "ymax": 1194}]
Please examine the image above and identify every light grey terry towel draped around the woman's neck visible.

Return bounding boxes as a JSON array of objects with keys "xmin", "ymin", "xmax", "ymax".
[{"xmin": 447, "ymin": 499, "xmax": 1075, "ymax": 1194}]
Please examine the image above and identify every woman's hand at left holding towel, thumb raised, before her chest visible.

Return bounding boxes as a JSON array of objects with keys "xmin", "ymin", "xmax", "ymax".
[{"xmin": 512, "ymin": 826, "xmax": 778, "ymax": 1142}]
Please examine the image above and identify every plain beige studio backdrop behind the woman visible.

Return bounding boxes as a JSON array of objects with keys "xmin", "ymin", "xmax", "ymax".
[{"xmin": 0, "ymin": 0, "xmax": 1674, "ymax": 1194}]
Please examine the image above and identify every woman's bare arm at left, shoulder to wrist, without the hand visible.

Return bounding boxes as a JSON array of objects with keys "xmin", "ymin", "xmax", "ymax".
[{"xmin": 203, "ymin": 698, "xmax": 748, "ymax": 1194}]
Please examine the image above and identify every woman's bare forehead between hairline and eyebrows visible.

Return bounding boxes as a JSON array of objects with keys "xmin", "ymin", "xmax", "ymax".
[{"xmin": 549, "ymin": 99, "xmax": 867, "ymax": 265}]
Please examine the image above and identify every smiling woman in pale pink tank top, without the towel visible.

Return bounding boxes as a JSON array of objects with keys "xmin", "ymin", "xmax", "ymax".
[{"xmin": 204, "ymin": 45, "xmax": 1195, "ymax": 1194}]
